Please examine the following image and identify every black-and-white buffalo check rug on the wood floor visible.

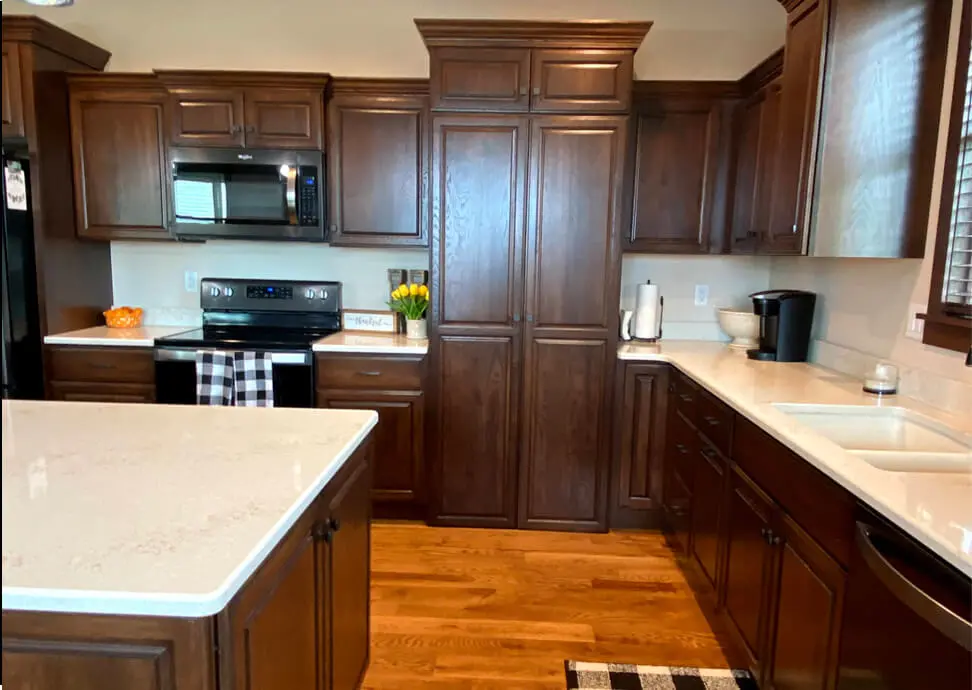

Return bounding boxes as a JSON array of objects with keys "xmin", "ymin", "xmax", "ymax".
[{"xmin": 564, "ymin": 661, "xmax": 759, "ymax": 690}]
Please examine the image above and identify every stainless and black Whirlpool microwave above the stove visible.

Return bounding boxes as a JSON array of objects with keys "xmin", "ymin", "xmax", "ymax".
[{"xmin": 169, "ymin": 148, "xmax": 325, "ymax": 242}]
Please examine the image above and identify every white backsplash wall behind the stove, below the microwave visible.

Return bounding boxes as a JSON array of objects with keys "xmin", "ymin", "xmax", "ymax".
[{"xmin": 111, "ymin": 241, "xmax": 429, "ymax": 326}]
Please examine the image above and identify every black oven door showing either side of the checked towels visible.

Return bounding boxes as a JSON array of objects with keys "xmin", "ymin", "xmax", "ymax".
[{"xmin": 155, "ymin": 347, "xmax": 314, "ymax": 407}]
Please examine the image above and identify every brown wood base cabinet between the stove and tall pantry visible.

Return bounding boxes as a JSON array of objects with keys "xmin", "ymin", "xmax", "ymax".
[{"xmin": 315, "ymin": 353, "xmax": 427, "ymax": 519}]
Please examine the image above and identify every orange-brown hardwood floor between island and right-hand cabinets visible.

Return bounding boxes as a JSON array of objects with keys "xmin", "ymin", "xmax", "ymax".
[{"xmin": 364, "ymin": 523, "xmax": 741, "ymax": 690}]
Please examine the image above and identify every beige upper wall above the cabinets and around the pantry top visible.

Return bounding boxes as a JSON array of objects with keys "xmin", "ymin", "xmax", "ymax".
[{"xmin": 2, "ymin": 0, "xmax": 785, "ymax": 80}]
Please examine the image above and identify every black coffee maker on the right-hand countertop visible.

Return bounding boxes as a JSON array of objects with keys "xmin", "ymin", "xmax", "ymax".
[{"xmin": 746, "ymin": 290, "xmax": 817, "ymax": 362}]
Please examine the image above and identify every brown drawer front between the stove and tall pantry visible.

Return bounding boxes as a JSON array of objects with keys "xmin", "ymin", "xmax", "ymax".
[{"xmin": 316, "ymin": 355, "xmax": 423, "ymax": 390}]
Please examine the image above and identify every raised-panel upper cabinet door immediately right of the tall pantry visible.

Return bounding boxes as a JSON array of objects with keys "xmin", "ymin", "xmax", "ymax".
[{"xmin": 629, "ymin": 100, "xmax": 720, "ymax": 254}]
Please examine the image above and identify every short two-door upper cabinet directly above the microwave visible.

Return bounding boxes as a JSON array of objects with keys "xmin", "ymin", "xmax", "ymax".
[{"xmin": 156, "ymin": 72, "xmax": 328, "ymax": 150}]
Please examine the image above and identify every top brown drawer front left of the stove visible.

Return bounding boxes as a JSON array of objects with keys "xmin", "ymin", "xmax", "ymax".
[{"xmin": 48, "ymin": 347, "xmax": 155, "ymax": 384}]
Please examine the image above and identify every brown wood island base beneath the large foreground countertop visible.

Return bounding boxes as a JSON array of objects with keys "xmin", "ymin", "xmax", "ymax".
[{"xmin": 3, "ymin": 440, "xmax": 374, "ymax": 690}]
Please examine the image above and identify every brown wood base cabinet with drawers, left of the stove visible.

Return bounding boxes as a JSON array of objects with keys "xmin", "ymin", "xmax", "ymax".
[{"xmin": 45, "ymin": 345, "xmax": 155, "ymax": 403}]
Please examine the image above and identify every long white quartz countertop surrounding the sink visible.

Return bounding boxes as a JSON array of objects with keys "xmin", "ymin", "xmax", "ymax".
[{"xmin": 618, "ymin": 341, "xmax": 972, "ymax": 577}]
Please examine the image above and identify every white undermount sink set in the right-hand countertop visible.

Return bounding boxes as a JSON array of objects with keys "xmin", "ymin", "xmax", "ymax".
[{"xmin": 773, "ymin": 403, "xmax": 972, "ymax": 473}]
